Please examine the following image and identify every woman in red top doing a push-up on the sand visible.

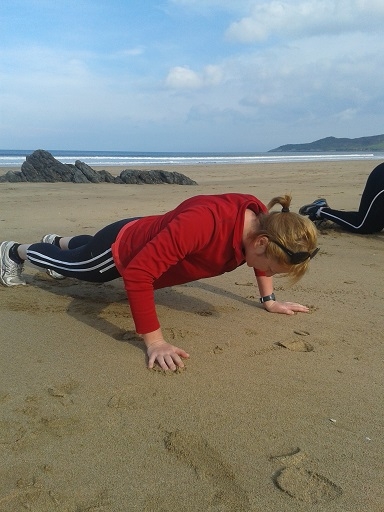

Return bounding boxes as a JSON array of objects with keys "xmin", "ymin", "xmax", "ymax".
[{"xmin": 0, "ymin": 193, "xmax": 319, "ymax": 371}]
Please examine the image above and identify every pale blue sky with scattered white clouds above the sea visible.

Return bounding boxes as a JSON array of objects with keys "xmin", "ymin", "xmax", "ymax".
[{"xmin": 0, "ymin": 0, "xmax": 384, "ymax": 152}]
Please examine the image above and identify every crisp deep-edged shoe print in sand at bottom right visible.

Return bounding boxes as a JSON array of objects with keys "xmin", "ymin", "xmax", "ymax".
[{"xmin": 271, "ymin": 448, "xmax": 343, "ymax": 505}]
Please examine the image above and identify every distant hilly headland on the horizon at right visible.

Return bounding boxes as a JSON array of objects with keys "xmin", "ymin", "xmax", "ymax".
[{"xmin": 268, "ymin": 135, "xmax": 384, "ymax": 153}]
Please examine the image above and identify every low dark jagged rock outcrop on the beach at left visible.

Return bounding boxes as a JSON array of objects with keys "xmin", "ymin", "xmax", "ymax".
[{"xmin": 0, "ymin": 149, "xmax": 197, "ymax": 185}]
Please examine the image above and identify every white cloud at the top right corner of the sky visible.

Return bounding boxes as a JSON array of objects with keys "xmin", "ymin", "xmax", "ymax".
[{"xmin": 226, "ymin": 0, "xmax": 384, "ymax": 43}]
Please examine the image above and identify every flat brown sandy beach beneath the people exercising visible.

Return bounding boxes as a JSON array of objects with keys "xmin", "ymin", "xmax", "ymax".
[{"xmin": 0, "ymin": 160, "xmax": 384, "ymax": 512}]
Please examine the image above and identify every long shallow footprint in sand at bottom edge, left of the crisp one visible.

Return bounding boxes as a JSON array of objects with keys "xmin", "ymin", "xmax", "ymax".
[{"xmin": 164, "ymin": 430, "xmax": 250, "ymax": 512}]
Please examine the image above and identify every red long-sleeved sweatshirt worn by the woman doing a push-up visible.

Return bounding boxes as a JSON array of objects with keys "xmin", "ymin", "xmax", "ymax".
[{"xmin": 112, "ymin": 193, "xmax": 267, "ymax": 334}]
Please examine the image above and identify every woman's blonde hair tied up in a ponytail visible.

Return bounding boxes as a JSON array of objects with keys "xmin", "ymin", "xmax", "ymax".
[{"xmin": 257, "ymin": 194, "xmax": 317, "ymax": 282}]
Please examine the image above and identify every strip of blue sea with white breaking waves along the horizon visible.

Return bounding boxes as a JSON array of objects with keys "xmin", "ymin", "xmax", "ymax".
[{"xmin": 0, "ymin": 150, "xmax": 384, "ymax": 168}]
